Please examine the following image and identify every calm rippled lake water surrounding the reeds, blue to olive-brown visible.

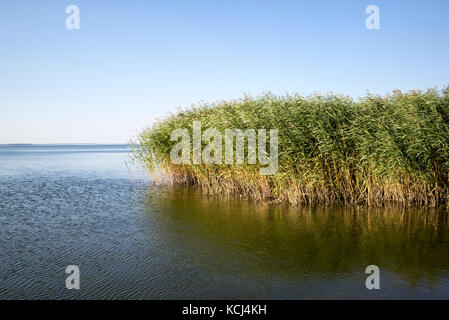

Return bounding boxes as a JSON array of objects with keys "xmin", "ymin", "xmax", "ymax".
[{"xmin": 0, "ymin": 145, "xmax": 449, "ymax": 299}]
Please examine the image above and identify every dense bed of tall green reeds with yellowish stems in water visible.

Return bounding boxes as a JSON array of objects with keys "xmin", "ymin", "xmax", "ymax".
[{"xmin": 133, "ymin": 87, "xmax": 449, "ymax": 207}]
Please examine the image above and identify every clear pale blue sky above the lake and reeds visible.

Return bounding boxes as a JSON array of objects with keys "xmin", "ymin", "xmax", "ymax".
[{"xmin": 0, "ymin": 0, "xmax": 449, "ymax": 144}]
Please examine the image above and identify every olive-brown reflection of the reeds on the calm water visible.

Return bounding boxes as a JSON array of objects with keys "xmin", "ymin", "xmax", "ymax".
[{"xmin": 141, "ymin": 187, "xmax": 449, "ymax": 298}]
